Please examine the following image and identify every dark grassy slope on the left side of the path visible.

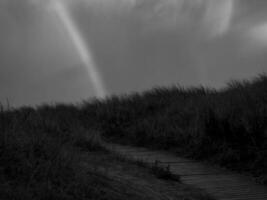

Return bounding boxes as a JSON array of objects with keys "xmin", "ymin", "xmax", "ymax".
[{"xmin": 0, "ymin": 105, "xmax": 214, "ymax": 200}]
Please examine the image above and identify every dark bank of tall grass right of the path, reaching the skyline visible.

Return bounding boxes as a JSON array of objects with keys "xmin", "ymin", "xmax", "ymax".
[{"xmin": 81, "ymin": 75, "xmax": 267, "ymax": 183}]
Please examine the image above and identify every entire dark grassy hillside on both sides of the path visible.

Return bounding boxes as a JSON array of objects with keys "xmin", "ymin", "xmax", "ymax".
[{"xmin": 0, "ymin": 75, "xmax": 267, "ymax": 199}]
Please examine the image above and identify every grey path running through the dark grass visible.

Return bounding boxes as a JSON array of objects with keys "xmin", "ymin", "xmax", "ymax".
[{"xmin": 108, "ymin": 144, "xmax": 267, "ymax": 200}]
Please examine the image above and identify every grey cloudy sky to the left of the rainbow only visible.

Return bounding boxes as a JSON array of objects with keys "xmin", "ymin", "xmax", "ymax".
[{"xmin": 0, "ymin": 0, "xmax": 91, "ymax": 105}]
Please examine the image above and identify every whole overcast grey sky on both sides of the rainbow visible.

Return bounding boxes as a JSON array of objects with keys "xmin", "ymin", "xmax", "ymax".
[{"xmin": 0, "ymin": 0, "xmax": 267, "ymax": 106}]
